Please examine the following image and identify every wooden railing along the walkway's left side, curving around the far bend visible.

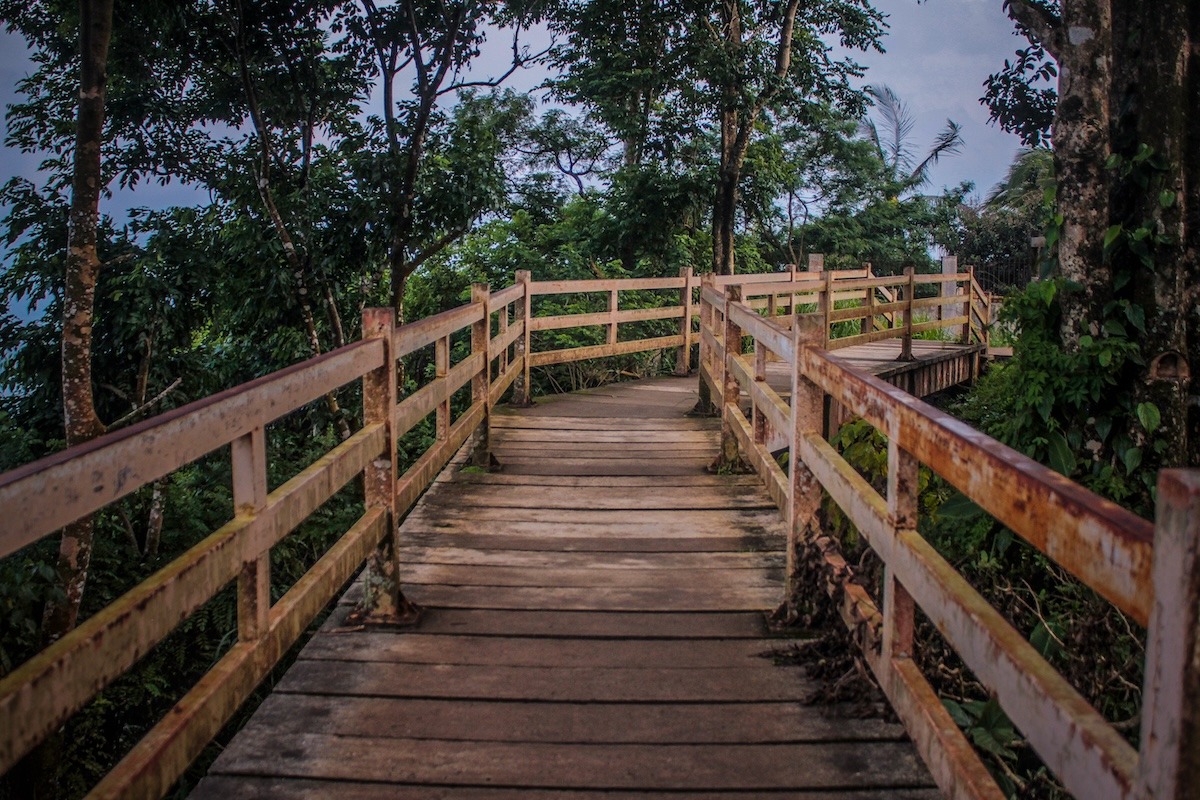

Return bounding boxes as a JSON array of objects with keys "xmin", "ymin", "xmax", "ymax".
[{"xmin": 0, "ymin": 261, "xmax": 1003, "ymax": 796}]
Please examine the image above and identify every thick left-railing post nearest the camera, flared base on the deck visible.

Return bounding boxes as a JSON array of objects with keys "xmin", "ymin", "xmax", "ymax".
[{"xmin": 358, "ymin": 308, "xmax": 419, "ymax": 622}]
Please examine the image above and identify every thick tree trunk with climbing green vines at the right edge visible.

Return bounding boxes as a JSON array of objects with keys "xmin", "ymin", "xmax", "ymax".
[{"xmin": 986, "ymin": 0, "xmax": 1200, "ymax": 465}]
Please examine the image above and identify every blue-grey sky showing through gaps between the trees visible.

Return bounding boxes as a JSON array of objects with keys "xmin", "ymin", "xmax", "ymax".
[{"xmin": 0, "ymin": 0, "xmax": 1020, "ymax": 218}]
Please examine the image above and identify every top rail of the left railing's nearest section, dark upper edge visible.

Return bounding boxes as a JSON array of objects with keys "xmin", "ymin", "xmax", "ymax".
[{"xmin": 0, "ymin": 341, "xmax": 383, "ymax": 558}]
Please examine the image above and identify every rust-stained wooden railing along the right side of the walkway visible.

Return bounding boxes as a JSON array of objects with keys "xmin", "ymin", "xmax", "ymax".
[{"xmin": 700, "ymin": 284, "xmax": 1200, "ymax": 800}]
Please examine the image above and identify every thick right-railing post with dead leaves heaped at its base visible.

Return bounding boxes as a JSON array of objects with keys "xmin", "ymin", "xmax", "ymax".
[{"xmin": 784, "ymin": 314, "xmax": 824, "ymax": 620}]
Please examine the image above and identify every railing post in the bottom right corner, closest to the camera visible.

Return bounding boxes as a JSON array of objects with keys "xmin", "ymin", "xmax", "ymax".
[{"xmin": 1134, "ymin": 469, "xmax": 1200, "ymax": 800}]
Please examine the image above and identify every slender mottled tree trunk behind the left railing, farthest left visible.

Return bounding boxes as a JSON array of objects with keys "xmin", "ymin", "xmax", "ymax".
[{"xmin": 42, "ymin": 0, "xmax": 113, "ymax": 642}]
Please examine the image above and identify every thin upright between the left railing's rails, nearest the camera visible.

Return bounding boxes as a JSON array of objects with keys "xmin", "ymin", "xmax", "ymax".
[{"xmin": 232, "ymin": 426, "xmax": 271, "ymax": 642}]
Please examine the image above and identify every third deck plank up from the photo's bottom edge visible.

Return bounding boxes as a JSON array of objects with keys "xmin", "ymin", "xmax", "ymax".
[{"xmin": 213, "ymin": 694, "xmax": 904, "ymax": 745}]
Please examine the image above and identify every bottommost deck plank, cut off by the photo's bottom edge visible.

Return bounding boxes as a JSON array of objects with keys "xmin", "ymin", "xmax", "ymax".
[{"xmin": 188, "ymin": 775, "xmax": 941, "ymax": 800}]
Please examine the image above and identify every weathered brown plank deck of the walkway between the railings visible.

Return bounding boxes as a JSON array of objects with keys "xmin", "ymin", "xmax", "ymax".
[{"xmin": 193, "ymin": 378, "xmax": 937, "ymax": 800}]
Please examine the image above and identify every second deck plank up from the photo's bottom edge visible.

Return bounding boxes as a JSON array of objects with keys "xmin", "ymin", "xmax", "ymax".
[{"xmin": 214, "ymin": 734, "xmax": 928, "ymax": 790}]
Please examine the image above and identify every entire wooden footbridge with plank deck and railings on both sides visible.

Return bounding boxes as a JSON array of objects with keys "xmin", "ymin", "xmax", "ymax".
[{"xmin": 0, "ymin": 266, "xmax": 1200, "ymax": 800}]
